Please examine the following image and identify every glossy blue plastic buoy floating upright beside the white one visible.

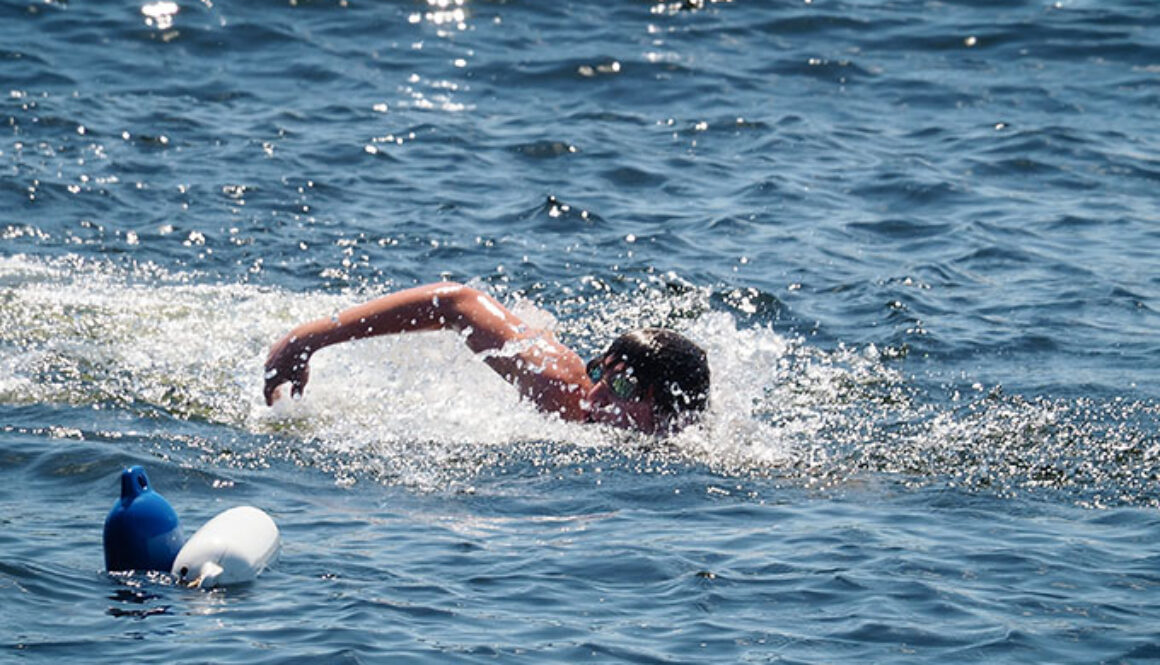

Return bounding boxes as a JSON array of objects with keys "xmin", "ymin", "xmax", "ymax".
[{"xmin": 104, "ymin": 467, "xmax": 186, "ymax": 572}]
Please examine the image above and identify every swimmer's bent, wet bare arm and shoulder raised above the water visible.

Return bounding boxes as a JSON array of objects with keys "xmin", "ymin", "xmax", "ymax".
[{"xmin": 263, "ymin": 282, "xmax": 592, "ymax": 420}]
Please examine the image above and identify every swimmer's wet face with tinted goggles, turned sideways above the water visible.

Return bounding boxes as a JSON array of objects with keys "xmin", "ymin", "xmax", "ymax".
[{"xmin": 587, "ymin": 355, "xmax": 657, "ymax": 434}]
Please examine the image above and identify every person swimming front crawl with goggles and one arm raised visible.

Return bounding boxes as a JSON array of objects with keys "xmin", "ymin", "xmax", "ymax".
[{"xmin": 264, "ymin": 282, "xmax": 709, "ymax": 434}]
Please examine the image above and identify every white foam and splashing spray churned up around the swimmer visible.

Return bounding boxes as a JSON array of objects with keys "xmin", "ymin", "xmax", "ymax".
[{"xmin": 0, "ymin": 256, "xmax": 1160, "ymax": 506}]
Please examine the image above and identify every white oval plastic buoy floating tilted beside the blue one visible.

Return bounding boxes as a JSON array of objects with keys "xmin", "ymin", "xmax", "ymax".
[{"xmin": 172, "ymin": 506, "xmax": 282, "ymax": 587}]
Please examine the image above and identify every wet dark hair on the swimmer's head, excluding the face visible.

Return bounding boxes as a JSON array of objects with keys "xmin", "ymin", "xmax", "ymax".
[{"xmin": 603, "ymin": 328, "xmax": 709, "ymax": 432}]
